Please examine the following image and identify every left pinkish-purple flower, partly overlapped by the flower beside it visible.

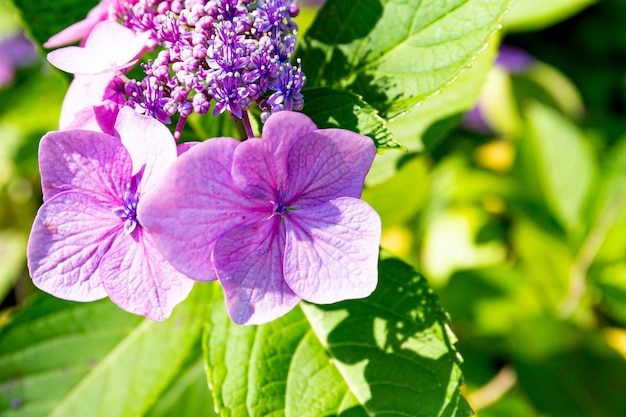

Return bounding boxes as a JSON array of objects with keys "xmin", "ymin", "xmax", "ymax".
[{"xmin": 27, "ymin": 107, "xmax": 193, "ymax": 321}]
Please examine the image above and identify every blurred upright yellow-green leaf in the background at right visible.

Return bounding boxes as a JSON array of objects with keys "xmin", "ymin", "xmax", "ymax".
[{"xmin": 525, "ymin": 102, "xmax": 596, "ymax": 237}]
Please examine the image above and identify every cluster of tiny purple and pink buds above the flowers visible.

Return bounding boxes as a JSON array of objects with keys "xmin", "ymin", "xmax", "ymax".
[{"xmin": 119, "ymin": 0, "xmax": 306, "ymax": 130}]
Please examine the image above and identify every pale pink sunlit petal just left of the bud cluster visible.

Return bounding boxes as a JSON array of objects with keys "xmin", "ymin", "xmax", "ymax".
[{"xmin": 48, "ymin": 20, "xmax": 150, "ymax": 74}]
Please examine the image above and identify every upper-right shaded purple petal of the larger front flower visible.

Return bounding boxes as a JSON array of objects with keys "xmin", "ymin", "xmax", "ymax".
[{"xmin": 285, "ymin": 129, "xmax": 376, "ymax": 208}]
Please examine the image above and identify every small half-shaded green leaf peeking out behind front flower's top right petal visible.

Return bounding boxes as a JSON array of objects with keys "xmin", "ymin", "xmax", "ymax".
[{"xmin": 304, "ymin": 88, "xmax": 402, "ymax": 151}]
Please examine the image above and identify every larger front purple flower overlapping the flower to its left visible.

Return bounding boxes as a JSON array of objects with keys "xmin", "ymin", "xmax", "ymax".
[{"xmin": 138, "ymin": 111, "xmax": 381, "ymax": 324}]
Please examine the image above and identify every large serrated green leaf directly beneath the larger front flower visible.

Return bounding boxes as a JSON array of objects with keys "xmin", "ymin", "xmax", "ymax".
[{"xmin": 204, "ymin": 259, "xmax": 472, "ymax": 417}]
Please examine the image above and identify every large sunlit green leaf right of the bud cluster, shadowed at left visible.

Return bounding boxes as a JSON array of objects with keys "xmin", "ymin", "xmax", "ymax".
[{"xmin": 296, "ymin": 0, "xmax": 510, "ymax": 118}]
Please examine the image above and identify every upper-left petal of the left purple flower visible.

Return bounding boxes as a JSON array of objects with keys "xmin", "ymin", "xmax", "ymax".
[{"xmin": 39, "ymin": 130, "xmax": 132, "ymax": 205}]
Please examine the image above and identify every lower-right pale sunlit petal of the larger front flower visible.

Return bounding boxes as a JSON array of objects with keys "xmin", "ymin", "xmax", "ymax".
[{"xmin": 284, "ymin": 197, "xmax": 381, "ymax": 304}]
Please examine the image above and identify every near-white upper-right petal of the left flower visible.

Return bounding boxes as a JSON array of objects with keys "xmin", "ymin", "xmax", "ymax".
[{"xmin": 115, "ymin": 107, "xmax": 176, "ymax": 193}]
